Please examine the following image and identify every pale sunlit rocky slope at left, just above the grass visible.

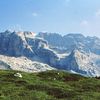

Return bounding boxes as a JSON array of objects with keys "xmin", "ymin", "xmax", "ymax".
[{"xmin": 0, "ymin": 55, "xmax": 54, "ymax": 72}]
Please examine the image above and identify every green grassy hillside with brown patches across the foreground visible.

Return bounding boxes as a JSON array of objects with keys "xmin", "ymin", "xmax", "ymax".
[{"xmin": 0, "ymin": 70, "xmax": 100, "ymax": 100}]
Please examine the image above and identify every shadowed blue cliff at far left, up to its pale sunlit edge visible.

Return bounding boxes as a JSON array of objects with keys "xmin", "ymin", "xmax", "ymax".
[{"xmin": 0, "ymin": 31, "xmax": 38, "ymax": 57}]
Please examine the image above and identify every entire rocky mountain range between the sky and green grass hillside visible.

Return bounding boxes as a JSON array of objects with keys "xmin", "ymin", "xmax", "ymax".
[{"xmin": 0, "ymin": 31, "xmax": 100, "ymax": 77}]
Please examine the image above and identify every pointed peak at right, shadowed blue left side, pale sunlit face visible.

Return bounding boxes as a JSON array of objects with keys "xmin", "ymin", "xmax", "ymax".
[{"xmin": 60, "ymin": 50, "xmax": 100, "ymax": 76}]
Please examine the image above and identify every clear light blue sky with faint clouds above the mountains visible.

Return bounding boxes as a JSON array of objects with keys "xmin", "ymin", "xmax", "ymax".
[{"xmin": 0, "ymin": 0, "xmax": 100, "ymax": 37}]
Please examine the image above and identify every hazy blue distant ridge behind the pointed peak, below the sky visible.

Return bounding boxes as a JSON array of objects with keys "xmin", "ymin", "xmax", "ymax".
[{"xmin": 37, "ymin": 32, "xmax": 100, "ymax": 55}]
